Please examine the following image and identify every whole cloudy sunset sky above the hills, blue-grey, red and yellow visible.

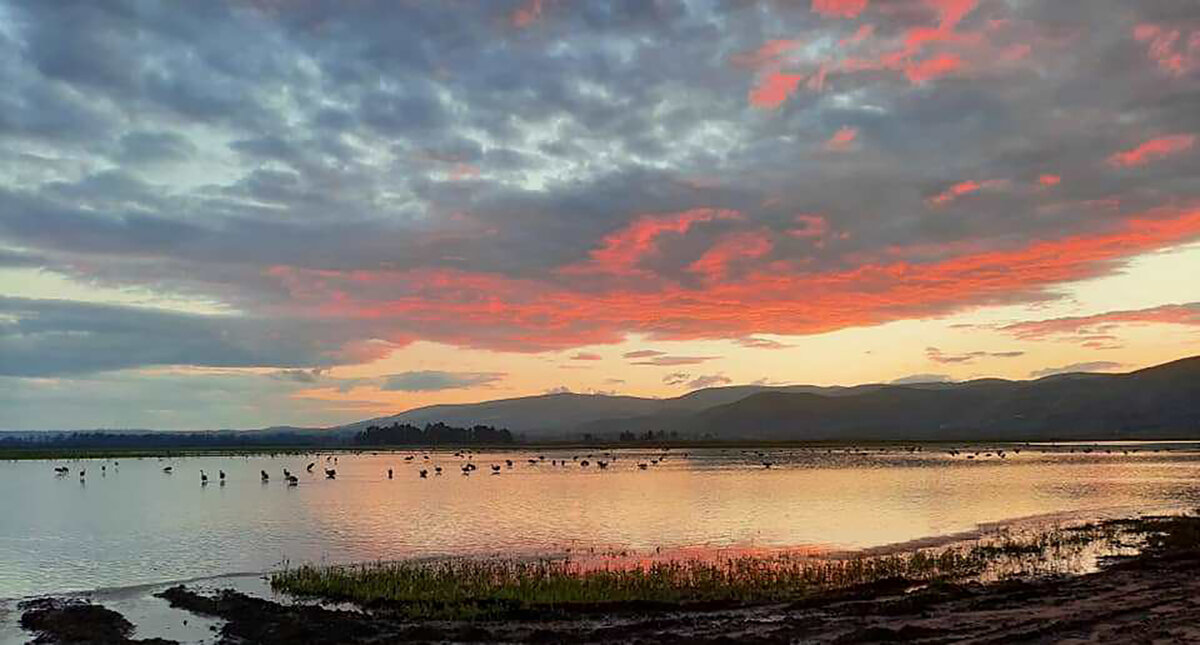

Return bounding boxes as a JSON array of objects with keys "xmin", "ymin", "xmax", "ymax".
[{"xmin": 0, "ymin": 0, "xmax": 1200, "ymax": 429}]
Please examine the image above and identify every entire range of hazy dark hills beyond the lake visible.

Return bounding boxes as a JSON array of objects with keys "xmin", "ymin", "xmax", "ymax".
[{"xmin": 335, "ymin": 357, "xmax": 1200, "ymax": 440}]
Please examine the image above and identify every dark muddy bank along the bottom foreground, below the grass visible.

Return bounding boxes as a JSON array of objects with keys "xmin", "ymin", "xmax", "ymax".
[{"xmin": 23, "ymin": 518, "xmax": 1200, "ymax": 644}]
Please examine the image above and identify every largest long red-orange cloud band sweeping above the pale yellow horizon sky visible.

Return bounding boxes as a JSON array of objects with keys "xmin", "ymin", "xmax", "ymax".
[{"xmin": 270, "ymin": 209, "xmax": 1200, "ymax": 351}]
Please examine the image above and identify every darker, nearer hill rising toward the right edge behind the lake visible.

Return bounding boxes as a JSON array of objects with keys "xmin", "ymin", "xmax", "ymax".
[{"xmin": 686, "ymin": 357, "xmax": 1200, "ymax": 440}]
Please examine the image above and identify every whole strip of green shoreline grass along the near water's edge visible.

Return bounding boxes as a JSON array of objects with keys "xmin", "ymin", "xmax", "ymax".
[{"xmin": 270, "ymin": 517, "xmax": 1200, "ymax": 620}]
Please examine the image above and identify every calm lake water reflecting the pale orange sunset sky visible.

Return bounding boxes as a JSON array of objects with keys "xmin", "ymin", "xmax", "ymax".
[{"xmin": 0, "ymin": 446, "xmax": 1200, "ymax": 597}]
